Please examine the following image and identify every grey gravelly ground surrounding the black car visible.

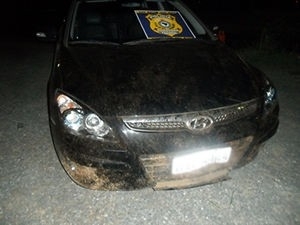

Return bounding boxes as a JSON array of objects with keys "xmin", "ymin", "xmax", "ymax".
[{"xmin": 0, "ymin": 42, "xmax": 300, "ymax": 225}]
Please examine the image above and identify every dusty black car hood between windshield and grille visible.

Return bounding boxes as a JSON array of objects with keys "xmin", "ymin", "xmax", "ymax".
[{"xmin": 59, "ymin": 40, "xmax": 259, "ymax": 116}]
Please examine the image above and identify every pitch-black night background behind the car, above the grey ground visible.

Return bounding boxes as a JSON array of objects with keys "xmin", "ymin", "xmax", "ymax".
[{"xmin": 0, "ymin": 0, "xmax": 300, "ymax": 49}]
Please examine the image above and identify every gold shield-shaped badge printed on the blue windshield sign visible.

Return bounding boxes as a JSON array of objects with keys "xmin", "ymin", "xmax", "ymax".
[{"xmin": 146, "ymin": 13, "xmax": 183, "ymax": 37}]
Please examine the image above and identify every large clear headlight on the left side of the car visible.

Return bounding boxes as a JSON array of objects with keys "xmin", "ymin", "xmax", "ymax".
[{"xmin": 56, "ymin": 94, "xmax": 113, "ymax": 140}]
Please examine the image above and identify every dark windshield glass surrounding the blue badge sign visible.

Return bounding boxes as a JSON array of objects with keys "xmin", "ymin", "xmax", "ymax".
[{"xmin": 70, "ymin": 0, "xmax": 207, "ymax": 43}]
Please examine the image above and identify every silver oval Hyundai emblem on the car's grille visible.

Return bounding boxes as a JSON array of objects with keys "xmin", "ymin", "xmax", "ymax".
[{"xmin": 186, "ymin": 115, "xmax": 213, "ymax": 132}]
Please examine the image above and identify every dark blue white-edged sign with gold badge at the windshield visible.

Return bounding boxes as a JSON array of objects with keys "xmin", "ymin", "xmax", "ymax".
[{"xmin": 135, "ymin": 10, "xmax": 195, "ymax": 39}]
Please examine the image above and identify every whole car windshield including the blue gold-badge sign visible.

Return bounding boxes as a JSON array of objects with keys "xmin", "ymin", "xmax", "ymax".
[{"xmin": 69, "ymin": 0, "xmax": 209, "ymax": 44}]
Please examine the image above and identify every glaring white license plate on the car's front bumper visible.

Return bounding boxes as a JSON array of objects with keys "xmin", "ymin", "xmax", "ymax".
[{"xmin": 172, "ymin": 147, "xmax": 231, "ymax": 174}]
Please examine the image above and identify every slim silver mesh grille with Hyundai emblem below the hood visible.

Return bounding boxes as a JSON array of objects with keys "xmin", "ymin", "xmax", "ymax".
[{"xmin": 122, "ymin": 99, "xmax": 258, "ymax": 132}]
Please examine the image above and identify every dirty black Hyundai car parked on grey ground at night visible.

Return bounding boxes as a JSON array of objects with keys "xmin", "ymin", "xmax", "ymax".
[{"xmin": 47, "ymin": 0, "xmax": 279, "ymax": 190}]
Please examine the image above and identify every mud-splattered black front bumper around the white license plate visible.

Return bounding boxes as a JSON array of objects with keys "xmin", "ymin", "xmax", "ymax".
[{"xmin": 50, "ymin": 103, "xmax": 279, "ymax": 190}]
